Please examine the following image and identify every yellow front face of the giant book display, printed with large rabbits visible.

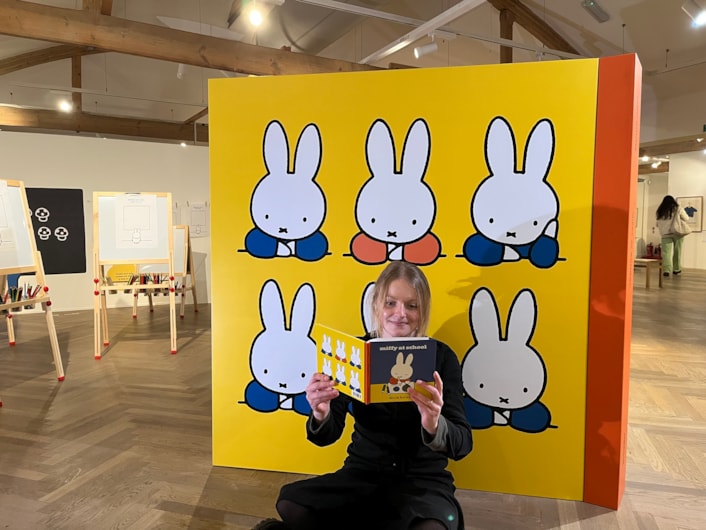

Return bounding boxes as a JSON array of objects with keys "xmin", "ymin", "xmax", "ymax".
[{"xmin": 209, "ymin": 58, "xmax": 635, "ymax": 506}]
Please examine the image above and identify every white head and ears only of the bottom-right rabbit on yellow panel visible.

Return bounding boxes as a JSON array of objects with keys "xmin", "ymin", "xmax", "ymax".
[{"xmin": 461, "ymin": 288, "xmax": 546, "ymax": 410}]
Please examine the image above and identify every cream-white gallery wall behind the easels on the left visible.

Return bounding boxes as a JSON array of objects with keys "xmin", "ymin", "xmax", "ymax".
[{"xmin": 0, "ymin": 131, "xmax": 211, "ymax": 311}]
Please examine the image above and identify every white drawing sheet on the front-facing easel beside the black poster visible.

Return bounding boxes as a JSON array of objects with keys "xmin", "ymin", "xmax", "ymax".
[{"xmin": 115, "ymin": 193, "xmax": 158, "ymax": 248}]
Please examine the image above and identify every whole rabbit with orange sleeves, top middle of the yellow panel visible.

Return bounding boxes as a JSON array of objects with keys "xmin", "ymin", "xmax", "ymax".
[{"xmin": 351, "ymin": 119, "xmax": 441, "ymax": 265}]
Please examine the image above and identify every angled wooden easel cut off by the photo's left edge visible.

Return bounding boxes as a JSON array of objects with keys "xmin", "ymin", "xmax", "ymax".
[{"xmin": 0, "ymin": 180, "xmax": 64, "ymax": 406}]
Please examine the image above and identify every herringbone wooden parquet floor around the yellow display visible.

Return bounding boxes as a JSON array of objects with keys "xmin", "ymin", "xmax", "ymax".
[{"xmin": 0, "ymin": 269, "xmax": 706, "ymax": 530}]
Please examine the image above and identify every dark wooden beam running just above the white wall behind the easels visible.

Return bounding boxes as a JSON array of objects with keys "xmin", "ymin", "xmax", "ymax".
[{"xmin": 0, "ymin": 106, "xmax": 208, "ymax": 143}]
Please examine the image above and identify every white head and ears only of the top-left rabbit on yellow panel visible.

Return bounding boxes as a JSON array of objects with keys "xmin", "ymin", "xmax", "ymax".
[{"xmin": 250, "ymin": 121, "xmax": 326, "ymax": 240}]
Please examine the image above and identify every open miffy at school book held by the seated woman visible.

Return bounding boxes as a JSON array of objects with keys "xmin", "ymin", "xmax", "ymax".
[{"xmin": 312, "ymin": 324, "xmax": 436, "ymax": 404}]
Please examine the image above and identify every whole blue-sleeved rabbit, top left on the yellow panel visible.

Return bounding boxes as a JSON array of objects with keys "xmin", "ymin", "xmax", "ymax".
[{"xmin": 245, "ymin": 120, "xmax": 328, "ymax": 261}]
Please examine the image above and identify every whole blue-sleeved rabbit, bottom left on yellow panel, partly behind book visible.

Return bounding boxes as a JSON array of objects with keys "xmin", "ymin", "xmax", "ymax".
[{"xmin": 245, "ymin": 280, "xmax": 316, "ymax": 414}]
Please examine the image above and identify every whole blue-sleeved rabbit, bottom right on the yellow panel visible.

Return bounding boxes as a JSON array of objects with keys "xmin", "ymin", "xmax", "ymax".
[{"xmin": 462, "ymin": 288, "xmax": 551, "ymax": 432}]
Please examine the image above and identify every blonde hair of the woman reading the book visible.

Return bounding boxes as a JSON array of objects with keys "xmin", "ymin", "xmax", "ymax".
[{"xmin": 370, "ymin": 261, "xmax": 431, "ymax": 337}]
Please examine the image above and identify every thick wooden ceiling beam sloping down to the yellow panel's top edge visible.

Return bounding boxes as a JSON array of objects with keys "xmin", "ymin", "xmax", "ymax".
[{"xmin": 0, "ymin": 0, "xmax": 379, "ymax": 75}]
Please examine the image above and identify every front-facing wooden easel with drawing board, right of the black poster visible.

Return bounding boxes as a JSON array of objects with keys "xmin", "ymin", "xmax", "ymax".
[{"xmin": 93, "ymin": 192, "xmax": 177, "ymax": 359}]
